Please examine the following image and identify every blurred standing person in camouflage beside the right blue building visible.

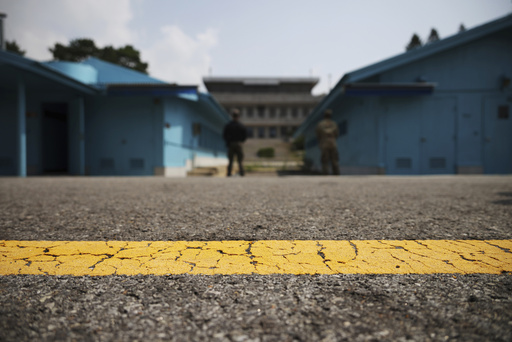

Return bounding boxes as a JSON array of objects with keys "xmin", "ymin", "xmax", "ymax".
[{"xmin": 316, "ymin": 109, "xmax": 340, "ymax": 175}]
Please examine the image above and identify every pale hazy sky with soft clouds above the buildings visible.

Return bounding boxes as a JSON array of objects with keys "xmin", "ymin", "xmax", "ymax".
[{"xmin": 0, "ymin": 0, "xmax": 512, "ymax": 94}]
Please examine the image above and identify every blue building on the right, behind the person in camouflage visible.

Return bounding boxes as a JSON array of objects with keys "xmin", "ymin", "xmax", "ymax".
[{"xmin": 295, "ymin": 16, "xmax": 512, "ymax": 175}]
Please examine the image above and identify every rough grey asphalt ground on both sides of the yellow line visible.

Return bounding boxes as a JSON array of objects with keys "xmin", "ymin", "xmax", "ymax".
[{"xmin": 0, "ymin": 176, "xmax": 512, "ymax": 341}]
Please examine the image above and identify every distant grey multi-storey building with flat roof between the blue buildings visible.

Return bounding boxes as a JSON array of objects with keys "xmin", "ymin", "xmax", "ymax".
[{"xmin": 203, "ymin": 77, "xmax": 322, "ymax": 140}]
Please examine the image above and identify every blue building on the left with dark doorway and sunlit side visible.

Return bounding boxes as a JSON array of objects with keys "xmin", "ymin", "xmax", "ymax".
[{"xmin": 0, "ymin": 51, "xmax": 229, "ymax": 176}]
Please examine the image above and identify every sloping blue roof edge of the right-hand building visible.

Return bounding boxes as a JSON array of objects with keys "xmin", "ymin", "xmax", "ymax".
[{"xmin": 294, "ymin": 15, "xmax": 512, "ymax": 137}]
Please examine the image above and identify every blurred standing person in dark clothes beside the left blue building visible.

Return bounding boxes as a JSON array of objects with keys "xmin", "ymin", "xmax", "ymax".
[{"xmin": 222, "ymin": 109, "xmax": 247, "ymax": 177}]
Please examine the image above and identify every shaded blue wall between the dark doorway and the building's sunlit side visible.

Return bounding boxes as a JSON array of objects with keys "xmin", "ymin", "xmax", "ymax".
[{"xmin": 85, "ymin": 97, "xmax": 162, "ymax": 175}]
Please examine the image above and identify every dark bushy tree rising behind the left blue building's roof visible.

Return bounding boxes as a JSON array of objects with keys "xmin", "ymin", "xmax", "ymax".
[{"xmin": 49, "ymin": 38, "xmax": 148, "ymax": 74}]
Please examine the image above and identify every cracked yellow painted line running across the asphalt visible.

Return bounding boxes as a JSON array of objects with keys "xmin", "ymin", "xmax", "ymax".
[{"xmin": 0, "ymin": 240, "xmax": 512, "ymax": 276}]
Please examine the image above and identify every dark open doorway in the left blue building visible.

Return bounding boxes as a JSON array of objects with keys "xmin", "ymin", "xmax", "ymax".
[{"xmin": 42, "ymin": 103, "xmax": 69, "ymax": 174}]
